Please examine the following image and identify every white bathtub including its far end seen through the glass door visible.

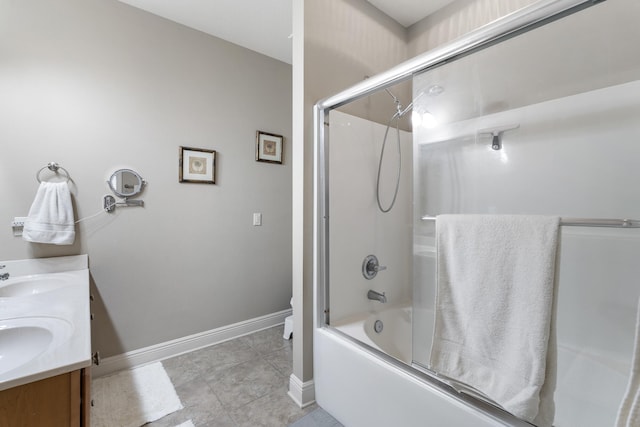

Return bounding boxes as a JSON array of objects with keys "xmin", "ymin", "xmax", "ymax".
[{"xmin": 314, "ymin": 305, "xmax": 629, "ymax": 427}]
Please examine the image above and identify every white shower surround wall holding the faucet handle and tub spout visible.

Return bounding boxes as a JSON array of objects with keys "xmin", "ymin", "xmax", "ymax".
[{"xmin": 329, "ymin": 110, "xmax": 412, "ymax": 322}]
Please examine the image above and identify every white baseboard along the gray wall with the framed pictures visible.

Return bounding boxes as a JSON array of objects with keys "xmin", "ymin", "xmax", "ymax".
[{"xmin": 91, "ymin": 309, "xmax": 291, "ymax": 378}]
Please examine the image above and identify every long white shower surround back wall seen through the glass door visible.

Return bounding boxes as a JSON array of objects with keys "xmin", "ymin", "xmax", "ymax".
[{"xmin": 414, "ymin": 78, "xmax": 640, "ymax": 427}]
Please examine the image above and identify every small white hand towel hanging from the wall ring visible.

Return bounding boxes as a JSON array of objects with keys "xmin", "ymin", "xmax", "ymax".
[{"xmin": 22, "ymin": 182, "xmax": 76, "ymax": 245}]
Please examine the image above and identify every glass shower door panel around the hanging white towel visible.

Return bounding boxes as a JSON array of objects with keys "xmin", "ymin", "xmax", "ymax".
[{"xmin": 413, "ymin": 1, "xmax": 640, "ymax": 427}]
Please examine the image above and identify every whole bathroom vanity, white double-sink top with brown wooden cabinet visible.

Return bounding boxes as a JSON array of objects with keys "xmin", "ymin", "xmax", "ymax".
[{"xmin": 0, "ymin": 255, "xmax": 91, "ymax": 427}]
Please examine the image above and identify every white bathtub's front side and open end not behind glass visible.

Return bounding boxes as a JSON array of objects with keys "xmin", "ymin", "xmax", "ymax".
[{"xmin": 314, "ymin": 305, "xmax": 531, "ymax": 427}]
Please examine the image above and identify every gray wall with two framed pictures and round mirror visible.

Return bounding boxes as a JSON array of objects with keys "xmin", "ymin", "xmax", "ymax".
[{"xmin": 0, "ymin": 0, "xmax": 292, "ymax": 356}]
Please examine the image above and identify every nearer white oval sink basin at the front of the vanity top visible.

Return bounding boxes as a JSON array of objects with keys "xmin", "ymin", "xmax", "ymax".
[{"xmin": 0, "ymin": 317, "xmax": 73, "ymax": 375}]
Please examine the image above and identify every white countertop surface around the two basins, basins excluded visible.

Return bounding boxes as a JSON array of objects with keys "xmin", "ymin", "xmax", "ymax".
[{"xmin": 0, "ymin": 255, "xmax": 91, "ymax": 390}]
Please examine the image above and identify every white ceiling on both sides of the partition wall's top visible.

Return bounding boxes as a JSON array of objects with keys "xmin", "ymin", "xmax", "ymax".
[{"xmin": 120, "ymin": 0, "xmax": 453, "ymax": 64}]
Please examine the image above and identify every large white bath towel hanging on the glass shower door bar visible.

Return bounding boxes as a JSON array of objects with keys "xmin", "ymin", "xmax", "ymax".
[{"xmin": 431, "ymin": 215, "xmax": 560, "ymax": 426}]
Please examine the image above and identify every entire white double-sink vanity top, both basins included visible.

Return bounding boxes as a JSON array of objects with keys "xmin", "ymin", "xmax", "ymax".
[{"xmin": 0, "ymin": 255, "xmax": 91, "ymax": 392}]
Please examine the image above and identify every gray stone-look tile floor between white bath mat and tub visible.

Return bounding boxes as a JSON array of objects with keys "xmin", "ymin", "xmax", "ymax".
[{"xmin": 147, "ymin": 326, "xmax": 318, "ymax": 427}]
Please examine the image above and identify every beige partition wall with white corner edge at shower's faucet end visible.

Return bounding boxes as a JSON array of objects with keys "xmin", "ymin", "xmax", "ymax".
[{"xmin": 290, "ymin": 0, "xmax": 406, "ymax": 388}]
